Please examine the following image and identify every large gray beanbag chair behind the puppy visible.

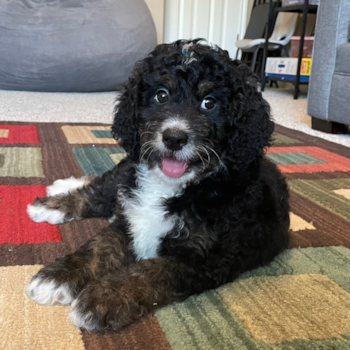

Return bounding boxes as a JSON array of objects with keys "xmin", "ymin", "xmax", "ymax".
[{"xmin": 0, "ymin": 0, "xmax": 156, "ymax": 92}]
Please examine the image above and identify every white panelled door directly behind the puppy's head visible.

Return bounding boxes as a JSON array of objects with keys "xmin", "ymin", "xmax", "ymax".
[{"xmin": 164, "ymin": 0, "xmax": 249, "ymax": 57}]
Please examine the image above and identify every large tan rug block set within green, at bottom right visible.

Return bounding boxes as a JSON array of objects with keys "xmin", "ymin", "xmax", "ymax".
[{"xmin": 218, "ymin": 275, "xmax": 349, "ymax": 344}]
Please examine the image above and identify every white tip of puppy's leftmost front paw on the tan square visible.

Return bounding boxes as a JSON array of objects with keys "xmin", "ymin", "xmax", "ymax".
[{"xmin": 27, "ymin": 276, "xmax": 73, "ymax": 305}]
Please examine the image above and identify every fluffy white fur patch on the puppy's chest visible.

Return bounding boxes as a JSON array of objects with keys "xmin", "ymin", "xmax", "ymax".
[{"xmin": 123, "ymin": 165, "xmax": 183, "ymax": 260}]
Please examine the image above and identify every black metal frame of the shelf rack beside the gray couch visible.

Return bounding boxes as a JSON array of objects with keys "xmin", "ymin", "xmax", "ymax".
[{"xmin": 261, "ymin": 0, "xmax": 318, "ymax": 100}]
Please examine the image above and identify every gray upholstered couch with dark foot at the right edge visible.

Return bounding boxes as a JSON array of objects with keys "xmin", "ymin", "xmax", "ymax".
[{"xmin": 307, "ymin": 0, "xmax": 350, "ymax": 132}]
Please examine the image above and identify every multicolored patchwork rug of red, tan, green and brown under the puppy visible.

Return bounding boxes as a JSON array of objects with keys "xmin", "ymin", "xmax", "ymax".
[{"xmin": 0, "ymin": 123, "xmax": 349, "ymax": 350}]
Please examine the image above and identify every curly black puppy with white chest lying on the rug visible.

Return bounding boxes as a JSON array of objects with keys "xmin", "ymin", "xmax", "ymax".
[{"xmin": 28, "ymin": 40, "xmax": 289, "ymax": 331}]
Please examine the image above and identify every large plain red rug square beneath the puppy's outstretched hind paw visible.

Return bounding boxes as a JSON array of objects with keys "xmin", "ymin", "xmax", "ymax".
[{"xmin": 0, "ymin": 185, "xmax": 62, "ymax": 244}]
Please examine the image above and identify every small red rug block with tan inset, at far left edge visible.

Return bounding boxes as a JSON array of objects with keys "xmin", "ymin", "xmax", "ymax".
[{"xmin": 0, "ymin": 125, "xmax": 39, "ymax": 143}]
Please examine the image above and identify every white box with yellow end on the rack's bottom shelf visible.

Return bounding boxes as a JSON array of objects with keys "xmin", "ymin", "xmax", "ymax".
[{"xmin": 265, "ymin": 57, "xmax": 312, "ymax": 76}]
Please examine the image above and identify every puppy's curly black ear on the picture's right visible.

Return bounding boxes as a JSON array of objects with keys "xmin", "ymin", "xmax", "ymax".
[{"xmin": 223, "ymin": 60, "xmax": 275, "ymax": 171}]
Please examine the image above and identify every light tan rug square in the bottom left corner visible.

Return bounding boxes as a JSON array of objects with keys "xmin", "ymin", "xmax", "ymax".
[{"xmin": 0, "ymin": 265, "xmax": 84, "ymax": 350}]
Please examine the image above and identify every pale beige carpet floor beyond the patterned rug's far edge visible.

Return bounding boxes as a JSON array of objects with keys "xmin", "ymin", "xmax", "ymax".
[{"xmin": 0, "ymin": 85, "xmax": 350, "ymax": 147}]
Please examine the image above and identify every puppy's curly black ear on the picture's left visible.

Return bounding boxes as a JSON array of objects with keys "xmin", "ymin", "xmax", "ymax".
[{"xmin": 112, "ymin": 71, "xmax": 140, "ymax": 159}]
